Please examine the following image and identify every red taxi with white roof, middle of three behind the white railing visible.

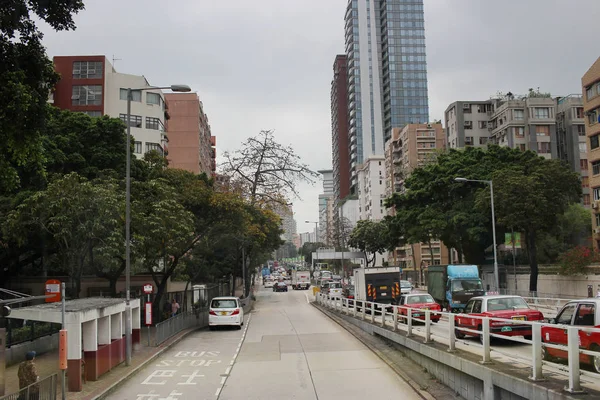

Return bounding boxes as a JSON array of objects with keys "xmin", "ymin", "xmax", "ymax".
[{"xmin": 456, "ymin": 295, "xmax": 544, "ymax": 339}]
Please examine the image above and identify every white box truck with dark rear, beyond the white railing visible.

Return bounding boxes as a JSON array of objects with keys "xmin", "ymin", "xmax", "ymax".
[{"xmin": 354, "ymin": 267, "xmax": 400, "ymax": 310}]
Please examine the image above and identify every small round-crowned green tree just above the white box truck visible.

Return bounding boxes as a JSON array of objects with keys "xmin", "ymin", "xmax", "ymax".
[{"xmin": 348, "ymin": 220, "xmax": 389, "ymax": 268}]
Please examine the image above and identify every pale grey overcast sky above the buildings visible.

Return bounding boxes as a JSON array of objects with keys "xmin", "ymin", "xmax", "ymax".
[{"xmin": 38, "ymin": 0, "xmax": 600, "ymax": 236}]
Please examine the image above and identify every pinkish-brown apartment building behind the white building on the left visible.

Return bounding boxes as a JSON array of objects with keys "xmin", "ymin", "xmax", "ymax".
[{"xmin": 165, "ymin": 93, "xmax": 217, "ymax": 176}]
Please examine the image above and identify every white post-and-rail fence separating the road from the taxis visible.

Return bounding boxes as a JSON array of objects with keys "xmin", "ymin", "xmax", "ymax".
[{"xmin": 316, "ymin": 293, "xmax": 600, "ymax": 393}]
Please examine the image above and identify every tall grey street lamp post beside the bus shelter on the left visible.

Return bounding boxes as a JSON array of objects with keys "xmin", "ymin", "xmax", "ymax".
[{"xmin": 125, "ymin": 85, "xmax": 192, "ymax": 366}]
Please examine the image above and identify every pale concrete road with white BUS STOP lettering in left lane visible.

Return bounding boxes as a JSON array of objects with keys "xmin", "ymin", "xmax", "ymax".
[{"xmin": 108, "ymin": 289, "xmax": 422, "ymax": 400}]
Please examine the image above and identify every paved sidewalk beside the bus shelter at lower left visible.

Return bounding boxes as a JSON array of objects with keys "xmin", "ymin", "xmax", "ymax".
[{"xmin": 5, "ymin": 328, "xmax": 197, "ymax": 400}]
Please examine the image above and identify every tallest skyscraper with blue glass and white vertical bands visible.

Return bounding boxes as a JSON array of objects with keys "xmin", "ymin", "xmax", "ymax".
[{"xmin": 345, "ymin": 0, "xmax": 429, "ymax": 194}]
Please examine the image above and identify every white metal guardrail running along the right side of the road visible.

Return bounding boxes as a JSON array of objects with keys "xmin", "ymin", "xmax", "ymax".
[{"xmin": 316, "ymin": 293, "xmax": 600, "ymax": 393}]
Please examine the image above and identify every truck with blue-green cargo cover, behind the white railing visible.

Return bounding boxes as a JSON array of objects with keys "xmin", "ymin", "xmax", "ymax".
[{"xmin": 427, "ymin": 265, "xmax": 485, "ymax": 313}]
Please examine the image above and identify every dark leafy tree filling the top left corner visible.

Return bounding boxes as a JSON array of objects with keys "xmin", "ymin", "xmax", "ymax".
[{"xmin": 0, "ymin": 0, "xmax": 84, "ymax": 191}]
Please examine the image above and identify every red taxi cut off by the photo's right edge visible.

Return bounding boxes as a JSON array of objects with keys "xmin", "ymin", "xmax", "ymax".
[{"xmin": 542, "ymin": 298, "xmax": 600, "ymax": 373}]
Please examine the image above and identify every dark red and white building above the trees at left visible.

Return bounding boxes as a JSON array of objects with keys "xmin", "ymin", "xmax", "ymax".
[{"xmin": 53, "ymin": 56, "xmax": 168, "ymax": 157}]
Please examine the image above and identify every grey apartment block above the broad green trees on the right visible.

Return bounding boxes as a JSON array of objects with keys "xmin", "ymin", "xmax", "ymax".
[{"xmin": 444, "ymin": 94, "xmax": 590, "ymax": 206}]
